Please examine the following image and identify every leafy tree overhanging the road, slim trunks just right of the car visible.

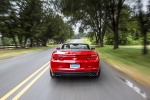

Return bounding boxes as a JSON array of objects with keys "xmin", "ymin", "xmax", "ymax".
[{"xmin": 54, "ymin": 0, "xmax": 107, "ymax": 46}]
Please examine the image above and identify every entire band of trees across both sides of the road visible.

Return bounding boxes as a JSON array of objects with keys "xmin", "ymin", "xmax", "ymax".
[{"xmin": 0, "ymin": 0, "xmax": 150, "ymax": 54}]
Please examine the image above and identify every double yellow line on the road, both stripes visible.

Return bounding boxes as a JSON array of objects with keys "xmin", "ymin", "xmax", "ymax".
[{"xmin": 0, "ymin": 62, "xmax": 49, "ymax": 100}]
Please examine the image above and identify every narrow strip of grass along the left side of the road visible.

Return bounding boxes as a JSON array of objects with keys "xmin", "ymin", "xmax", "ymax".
[{"xmin": 0, "ymin": 45, "xmax": 58, "ymax": 60}]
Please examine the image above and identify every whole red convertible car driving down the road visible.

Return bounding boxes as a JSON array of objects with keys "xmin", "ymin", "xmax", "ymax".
[{"xmin": 50, "ymin": 43, "xmax": 100, "ymax": 78}]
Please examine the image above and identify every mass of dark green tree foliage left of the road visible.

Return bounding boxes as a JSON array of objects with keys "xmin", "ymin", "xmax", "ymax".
[{"xmin": 0, "ymin": 0, "xmax": 74, "ymax": 47}]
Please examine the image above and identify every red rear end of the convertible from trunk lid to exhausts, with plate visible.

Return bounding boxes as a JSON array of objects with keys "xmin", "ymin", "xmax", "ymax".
[{"xmin": 50, "ymin": 50, "xmax": 100, "ymax": 76}]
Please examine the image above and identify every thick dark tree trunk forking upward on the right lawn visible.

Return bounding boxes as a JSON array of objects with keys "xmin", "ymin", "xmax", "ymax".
[{"xmin": 104, "ymin": 0, "xmax": 125, "ymax": 49}]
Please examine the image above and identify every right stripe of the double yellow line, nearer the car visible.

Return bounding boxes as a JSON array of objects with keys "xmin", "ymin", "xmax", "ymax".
[{"xmin": 12, "ymin": 67, "xmax": 49, "ymax": 100}]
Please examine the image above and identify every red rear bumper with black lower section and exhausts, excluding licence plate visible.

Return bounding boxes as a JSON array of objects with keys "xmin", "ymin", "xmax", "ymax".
[{"xmin": 50, "ymin": 60, "xmax": 100, "ymax": 76}]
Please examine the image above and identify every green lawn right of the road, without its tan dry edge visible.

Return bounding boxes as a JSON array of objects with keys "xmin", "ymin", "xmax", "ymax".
[{"xmin": 96, "ymin": 46, "xmax": 150, "ymax": 76}]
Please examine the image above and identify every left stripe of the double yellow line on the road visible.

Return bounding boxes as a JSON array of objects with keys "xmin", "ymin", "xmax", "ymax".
[{"xmin": 0, "ymin": 62, "xmax": 49, "ymax": 100}]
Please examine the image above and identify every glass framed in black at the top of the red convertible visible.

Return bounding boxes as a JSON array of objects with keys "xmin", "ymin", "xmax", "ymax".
[{"xmin": 61, "ymin": 44, "xmax": 90, "ymax": 49}]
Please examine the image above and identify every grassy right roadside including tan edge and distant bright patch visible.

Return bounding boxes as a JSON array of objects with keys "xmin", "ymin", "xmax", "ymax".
[{"xmin": 82, "ymin": 38, "xmax": 150, "ymax": 87}]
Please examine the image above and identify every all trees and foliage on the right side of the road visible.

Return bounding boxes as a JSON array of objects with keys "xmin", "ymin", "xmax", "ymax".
[{"xmin": 53, "ymin": 0, "xmax": 150, "ymax": 54}]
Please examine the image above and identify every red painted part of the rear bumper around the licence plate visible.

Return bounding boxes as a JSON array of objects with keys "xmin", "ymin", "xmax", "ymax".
[{"xmin": 50, "ymin": 60, "xmax": 100, "ymax": 69}]
